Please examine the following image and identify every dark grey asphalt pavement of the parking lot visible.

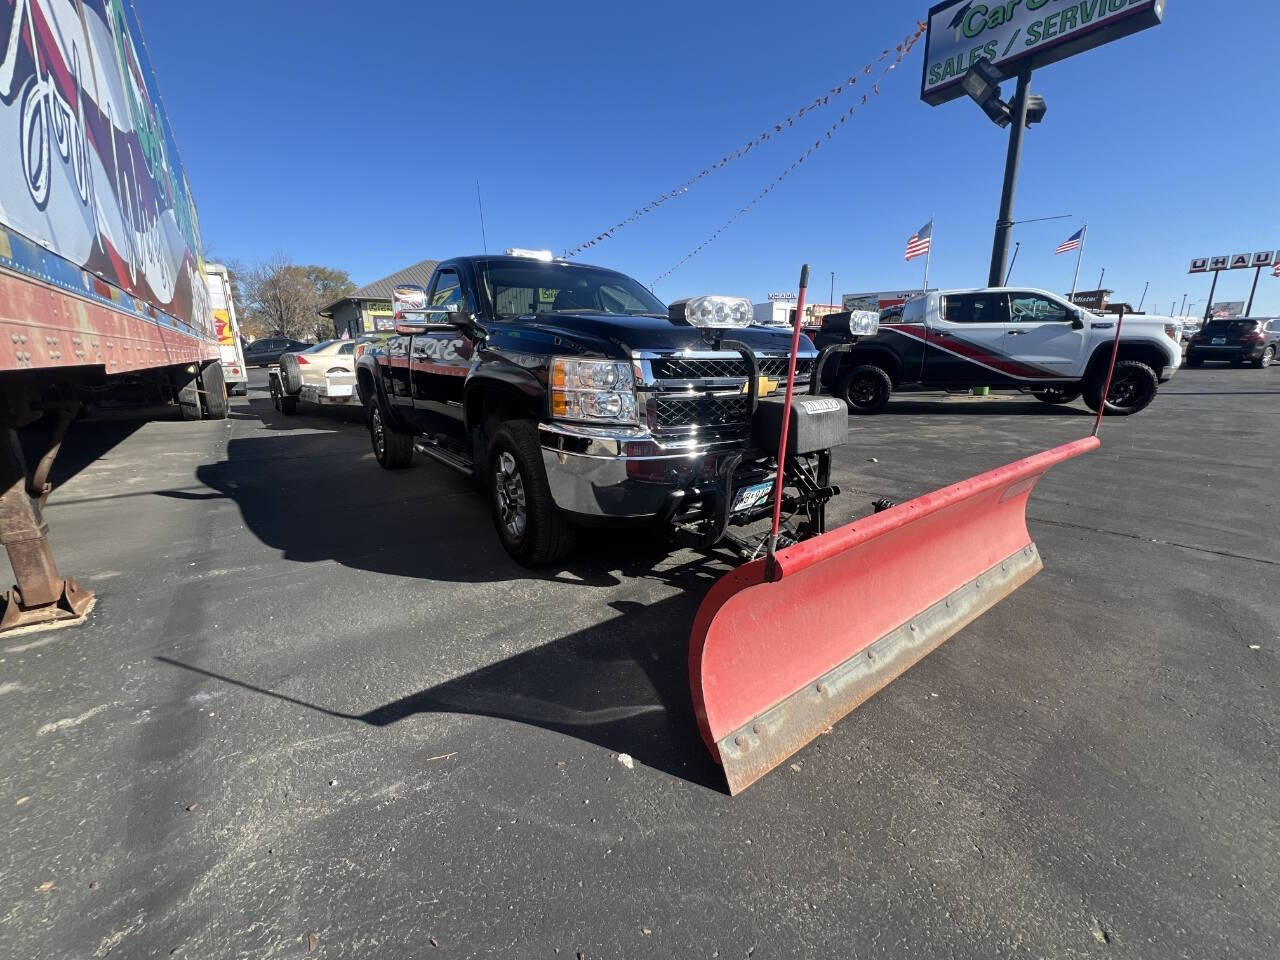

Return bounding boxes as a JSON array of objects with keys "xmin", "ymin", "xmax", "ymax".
[{"xmin": 0, "ymin": 369, "xmax": 1280, "ymax": 960}]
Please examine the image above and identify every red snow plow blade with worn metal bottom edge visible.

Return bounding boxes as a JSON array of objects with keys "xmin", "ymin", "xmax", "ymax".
[{"xmin": 689, "ymin": 436, "xmax": 1098, "ymax": 794}]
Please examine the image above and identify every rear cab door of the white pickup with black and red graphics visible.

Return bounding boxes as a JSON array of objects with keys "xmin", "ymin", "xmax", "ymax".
[{"xmin": 922, "ymin": 291, "xmax": 1018, "ymax": 387}]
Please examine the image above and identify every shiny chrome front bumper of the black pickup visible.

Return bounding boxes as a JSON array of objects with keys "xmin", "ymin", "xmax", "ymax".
[{"xmin": 538, "ymin": 424, "xmax": 742, "ymax": 520}]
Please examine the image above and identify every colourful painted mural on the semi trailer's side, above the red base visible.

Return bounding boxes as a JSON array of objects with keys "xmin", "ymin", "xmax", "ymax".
[{"xmin": 0, "ymin": 0, "xmax": 212, "ymax": 335}]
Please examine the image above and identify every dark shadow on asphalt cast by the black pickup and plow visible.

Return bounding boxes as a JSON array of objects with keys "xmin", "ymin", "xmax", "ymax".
[{"xmin": 180, "ymin": 403, "xmax": 728, "ymax": 790}]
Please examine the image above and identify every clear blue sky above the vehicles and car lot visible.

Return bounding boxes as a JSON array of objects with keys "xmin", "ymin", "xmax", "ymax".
[{"xmin": 134, "ymin": 0, "xmax": 1280, "ymax": 315}]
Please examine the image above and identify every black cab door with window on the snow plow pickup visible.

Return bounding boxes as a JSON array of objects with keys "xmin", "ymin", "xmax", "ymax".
[{"xmin": 410, "ymin": 269, "xmax": 476, "ymax": 448}]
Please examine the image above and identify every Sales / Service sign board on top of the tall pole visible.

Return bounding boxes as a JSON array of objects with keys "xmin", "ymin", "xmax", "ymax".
[{"xmin": 920, "ymin": 0, "xmax": 1165, "ymax": 106}]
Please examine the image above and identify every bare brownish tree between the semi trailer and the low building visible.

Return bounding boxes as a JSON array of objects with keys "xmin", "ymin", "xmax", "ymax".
[{"xmin": 232, "ymin": 253, "xmax": 356, "ymax": 339}]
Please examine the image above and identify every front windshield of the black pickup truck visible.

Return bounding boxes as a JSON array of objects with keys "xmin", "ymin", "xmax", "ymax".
[{"xmin": 476, "ymin": 261, "xmax": 667, "ymax": 320}]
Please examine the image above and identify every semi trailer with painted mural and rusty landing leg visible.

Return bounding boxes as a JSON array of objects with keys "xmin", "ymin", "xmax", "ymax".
[{"xmin": 0, "ymin": 0, "xmax": 227, "ymax": 630}]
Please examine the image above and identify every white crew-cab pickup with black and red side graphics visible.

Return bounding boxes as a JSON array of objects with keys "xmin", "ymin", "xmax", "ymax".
[{"xmin": 815, "ymin": 287, "xmax": 1183, "ymax": 416}]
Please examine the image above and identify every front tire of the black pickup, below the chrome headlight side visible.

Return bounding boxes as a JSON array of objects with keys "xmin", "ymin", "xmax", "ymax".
[{"xmin": 484, "ymin": 420, "xmax": 576, "ymax": 567}]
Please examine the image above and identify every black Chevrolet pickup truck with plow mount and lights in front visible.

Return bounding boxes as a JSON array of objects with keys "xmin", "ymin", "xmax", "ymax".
[{"xmin": 356, "ymin": 255, "xmax": 847, "ymax": 566}]
